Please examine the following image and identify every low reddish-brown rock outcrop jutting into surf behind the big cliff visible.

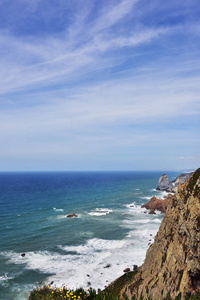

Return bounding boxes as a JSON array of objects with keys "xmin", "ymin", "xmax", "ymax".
[{"xmin": 141, "ymin": 194, "xmax": 174, "ymax": 214}]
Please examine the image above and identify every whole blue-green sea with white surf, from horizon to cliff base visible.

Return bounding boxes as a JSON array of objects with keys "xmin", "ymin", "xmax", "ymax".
[{"xmin": 0, "ymin": 172, "xmax": 178, "ymax": 300}]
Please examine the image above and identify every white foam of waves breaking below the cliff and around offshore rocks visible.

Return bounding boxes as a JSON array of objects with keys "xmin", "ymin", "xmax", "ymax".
[{"xmin": 1, "ymin": 196, "xmax": 161, "ymax": 289}]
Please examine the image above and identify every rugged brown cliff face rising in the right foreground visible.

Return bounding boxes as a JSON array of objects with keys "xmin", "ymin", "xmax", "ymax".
[{"xmin": 110, "ymin": 169, "xmax": 200, "ymax": 300}]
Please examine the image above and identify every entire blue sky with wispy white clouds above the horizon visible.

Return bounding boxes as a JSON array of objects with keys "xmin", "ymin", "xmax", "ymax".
[{"xmin": 0, "ymin": 0, "xmax": 200, "ymax": 171}]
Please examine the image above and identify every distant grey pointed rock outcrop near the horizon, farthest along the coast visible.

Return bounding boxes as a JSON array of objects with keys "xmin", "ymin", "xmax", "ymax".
[{"xmin": 156, "ymin": 172, "xmax": 194, "ymax": 193}]
